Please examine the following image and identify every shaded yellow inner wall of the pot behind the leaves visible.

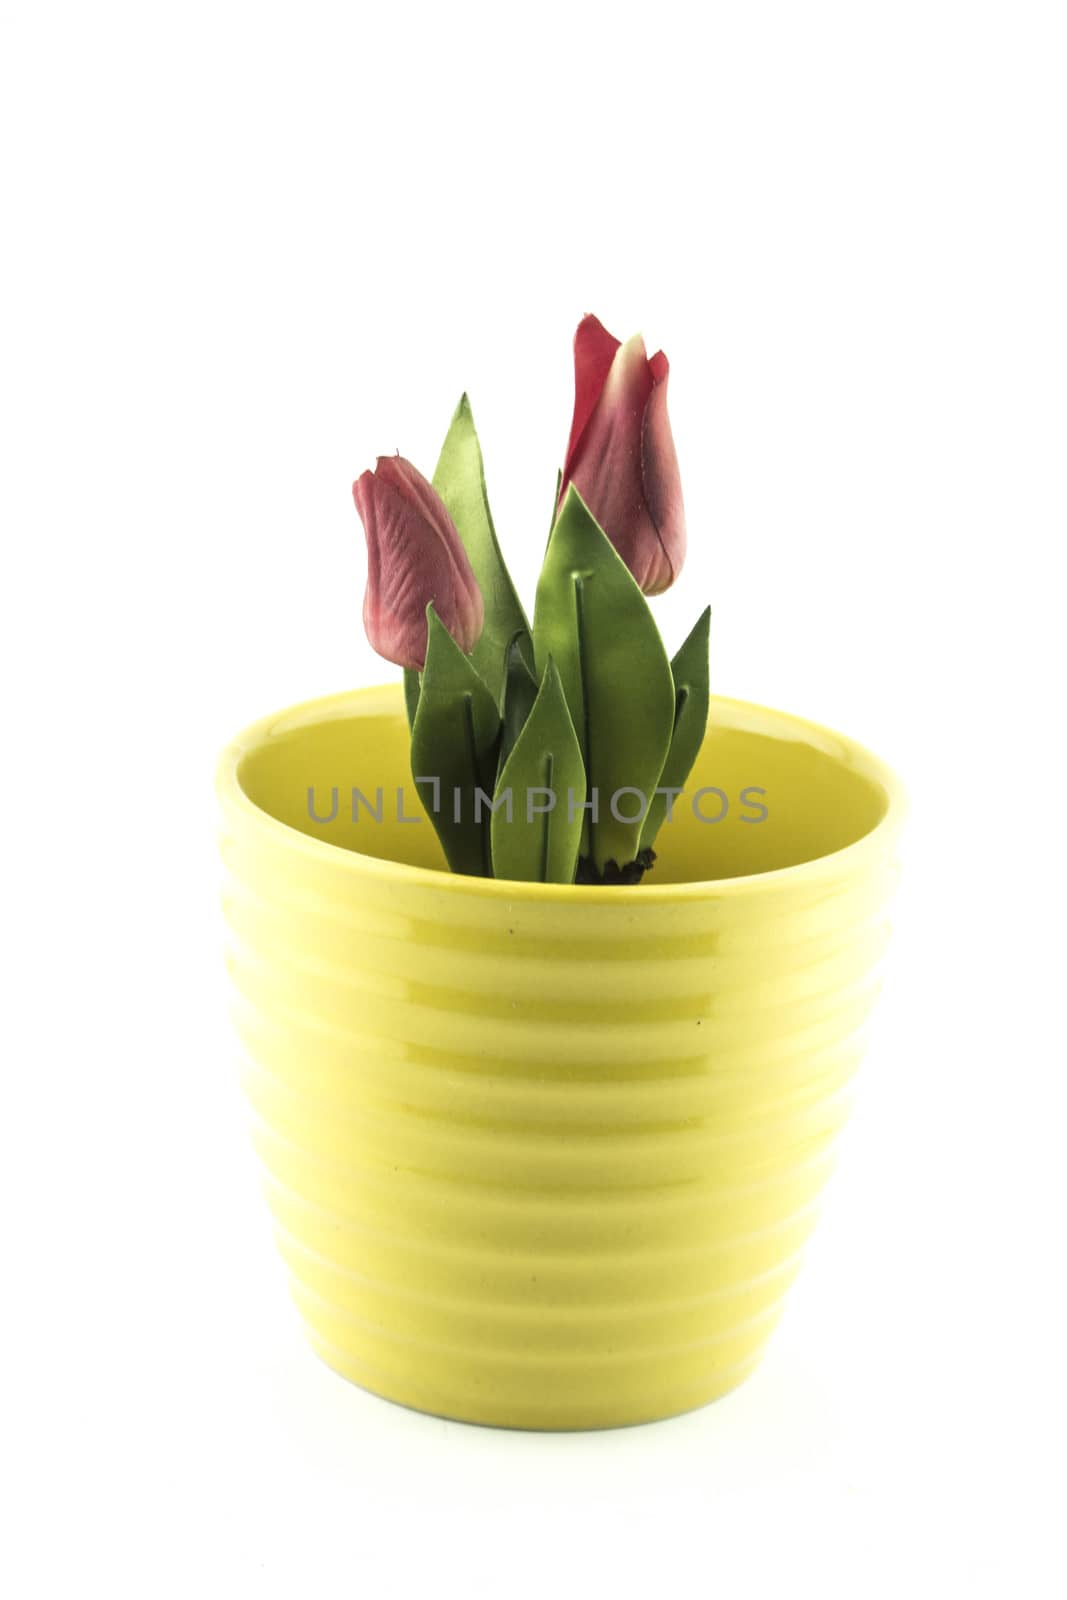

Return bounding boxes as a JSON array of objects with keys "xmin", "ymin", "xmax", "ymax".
[{"xmin": 237, "ymin": 686, "xmax": 891, "ymax": 883}]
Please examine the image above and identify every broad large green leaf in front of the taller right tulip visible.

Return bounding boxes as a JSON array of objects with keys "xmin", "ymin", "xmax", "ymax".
[{"xmin": 534, "ymin": 485, "xmax": 675, "ymax": 870}]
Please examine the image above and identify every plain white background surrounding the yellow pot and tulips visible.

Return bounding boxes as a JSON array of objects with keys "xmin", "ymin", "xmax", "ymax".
[{"xmin": 0, "ymin": 0, "xmax": 1067, "ymax": 1600}]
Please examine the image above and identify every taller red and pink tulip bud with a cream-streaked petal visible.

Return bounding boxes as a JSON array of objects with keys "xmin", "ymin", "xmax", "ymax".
[{"xmin": 558, "ymin": 317, "xmax": 685, "ymax": 595}]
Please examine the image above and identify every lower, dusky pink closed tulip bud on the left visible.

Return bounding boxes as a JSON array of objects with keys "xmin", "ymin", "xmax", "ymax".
[{"xmin": 352, "ymin": 456, "xmax": 483, "ymax": 669}]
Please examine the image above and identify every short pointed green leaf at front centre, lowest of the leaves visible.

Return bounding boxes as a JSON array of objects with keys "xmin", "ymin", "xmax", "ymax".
[{"xmin": 491, "ymin": 661, "xmax": 585, "ymax": 883}]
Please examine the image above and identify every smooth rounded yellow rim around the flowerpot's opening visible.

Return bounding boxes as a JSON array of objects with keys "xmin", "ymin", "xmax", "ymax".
[{"xmin": 216, "ymin": 683, "xmax": 907, "ymax": 906}]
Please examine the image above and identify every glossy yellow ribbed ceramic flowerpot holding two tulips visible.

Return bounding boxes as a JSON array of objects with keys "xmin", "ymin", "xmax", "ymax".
[{"xmin": 219, "ymin": 688, "xmax": 902, "ymax": 1429}]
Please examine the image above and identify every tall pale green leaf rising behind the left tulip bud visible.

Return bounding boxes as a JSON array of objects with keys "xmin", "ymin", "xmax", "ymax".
[{"xmin": 434, "ymin": 395, "xmax": 533, "ymax": 706}]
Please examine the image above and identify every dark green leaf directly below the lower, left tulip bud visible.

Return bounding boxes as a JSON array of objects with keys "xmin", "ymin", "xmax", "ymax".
[{"xmin": 411, "ymin": 605, "xmax": 501, "ymax": 878}]
